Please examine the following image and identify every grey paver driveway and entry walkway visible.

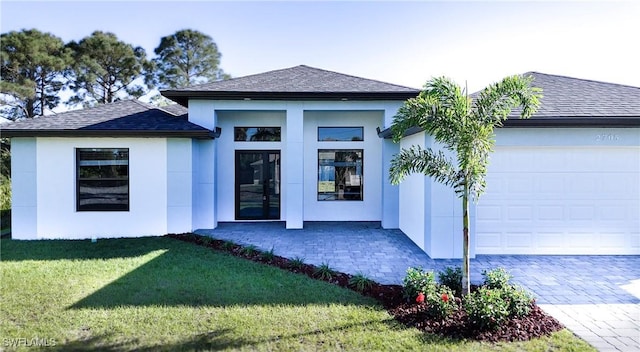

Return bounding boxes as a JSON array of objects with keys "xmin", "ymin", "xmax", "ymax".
[{"xmin": 197, "ymin": 222, "xmax": 640, "ymax": 351}]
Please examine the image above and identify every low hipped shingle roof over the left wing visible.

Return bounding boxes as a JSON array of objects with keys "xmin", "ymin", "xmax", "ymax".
[{"xmin": 0, "ymin": 100, "xmax": 211, "ymax": 138}]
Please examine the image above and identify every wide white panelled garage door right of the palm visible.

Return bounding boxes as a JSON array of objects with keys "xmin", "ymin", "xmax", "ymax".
[{"xmin": 476, "ymin": 146, "xmax": 640, "ymax": 254}]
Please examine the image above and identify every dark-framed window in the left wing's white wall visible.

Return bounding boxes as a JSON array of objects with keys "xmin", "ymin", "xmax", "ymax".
[{"xmin": 76, "ymin": 148, "xmax": 129, "ymax": 211}]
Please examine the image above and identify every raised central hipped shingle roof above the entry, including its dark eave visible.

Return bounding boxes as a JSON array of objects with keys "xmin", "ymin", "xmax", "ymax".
[{"xmin": 162, "ymin": 65, "xmax": 420, "ymax": 105}]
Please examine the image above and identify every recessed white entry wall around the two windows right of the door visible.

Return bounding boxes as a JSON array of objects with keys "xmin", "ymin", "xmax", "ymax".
[{"xmin": 304, "ymin": 110, "xmax": 385, "ymax": 221}]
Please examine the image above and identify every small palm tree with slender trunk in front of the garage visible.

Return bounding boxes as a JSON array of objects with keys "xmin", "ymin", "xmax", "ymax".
[{"xmin": 389, "ymin": 76, "xmax": 542, "ymax": 294}]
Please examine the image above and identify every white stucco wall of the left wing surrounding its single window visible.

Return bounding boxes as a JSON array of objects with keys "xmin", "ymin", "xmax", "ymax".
[{"xmin": 12, "ymin": 138, "xmax": 191, "ymax": 239}]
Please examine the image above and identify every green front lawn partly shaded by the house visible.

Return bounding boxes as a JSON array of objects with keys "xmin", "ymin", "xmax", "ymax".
[{"xmin": 0, "ymin": 237, "xmax": 589, "ymax": 351}]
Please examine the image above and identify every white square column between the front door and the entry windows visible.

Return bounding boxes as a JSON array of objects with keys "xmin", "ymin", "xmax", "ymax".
[{"xmin": 283, "ymin": 103, "xmax": 304, "ymax": 229}]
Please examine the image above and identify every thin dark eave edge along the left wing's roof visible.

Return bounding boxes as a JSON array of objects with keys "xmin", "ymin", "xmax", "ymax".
[{"xmin": 2, "ymin": 129, "xmax": 215, "ymax": 139}]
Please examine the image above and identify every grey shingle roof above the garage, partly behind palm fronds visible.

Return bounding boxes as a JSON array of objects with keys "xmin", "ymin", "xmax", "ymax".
[{"xmin": 505, "ymin": 72, "xmax": 640, "ymax": 126}]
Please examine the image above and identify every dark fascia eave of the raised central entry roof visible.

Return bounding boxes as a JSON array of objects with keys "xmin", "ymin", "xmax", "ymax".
[{"xmin": 160, "ymin": 90, "xmax": 420, "ymax": 106}]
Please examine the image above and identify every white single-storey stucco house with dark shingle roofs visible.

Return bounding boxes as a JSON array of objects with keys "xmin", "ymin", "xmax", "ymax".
[{"xmin": 0, "ymin": 66, "xmax": 640, "ymax": 258}]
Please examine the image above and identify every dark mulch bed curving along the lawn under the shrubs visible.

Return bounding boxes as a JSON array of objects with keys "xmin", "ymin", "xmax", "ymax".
[{"xmin": 167, "ymin": 233, "xmax": 564, "ymax": 342}]
